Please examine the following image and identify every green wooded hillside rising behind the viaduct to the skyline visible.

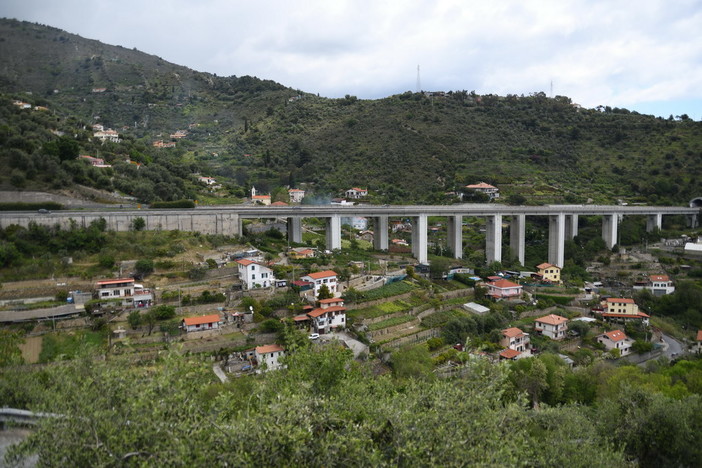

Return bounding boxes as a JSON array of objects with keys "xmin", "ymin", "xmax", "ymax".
[{"xmin": 0, "ymin": 20, "xmax": 702, "ymax": 204}]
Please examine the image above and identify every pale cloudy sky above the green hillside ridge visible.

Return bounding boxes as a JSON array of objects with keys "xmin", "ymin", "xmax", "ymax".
[{"xmin": 0, "ymin": 0, "xmax": 702, "ymax": 120}]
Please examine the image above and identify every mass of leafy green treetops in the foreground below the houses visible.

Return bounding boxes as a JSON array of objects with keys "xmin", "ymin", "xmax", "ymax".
[{"xmin": 0, "ymin": 347, "xmax": 702, "ymax": 467}]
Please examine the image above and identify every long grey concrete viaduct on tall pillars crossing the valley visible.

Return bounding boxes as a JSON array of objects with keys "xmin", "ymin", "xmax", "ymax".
[{"xmin": 0, "ymin": 203, "xmax": 700, "ymax": 266}]
